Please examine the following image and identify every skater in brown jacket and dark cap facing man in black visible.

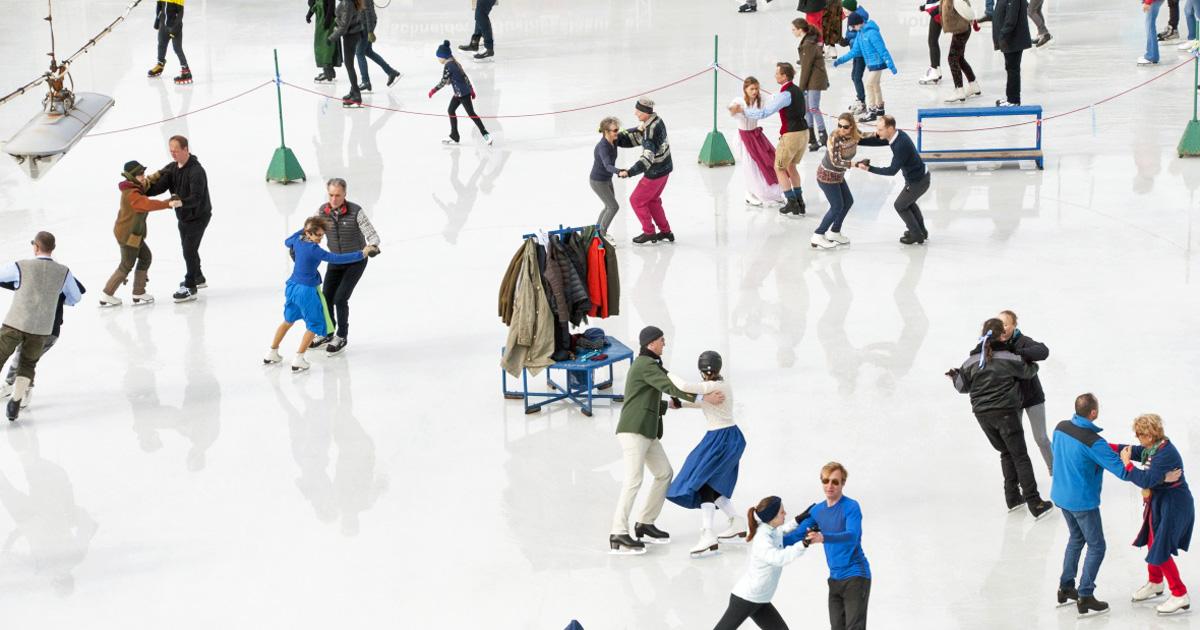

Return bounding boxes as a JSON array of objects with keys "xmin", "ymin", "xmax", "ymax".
[{"xmin": 100, "ymin": 160, "xmax": 184, "ymax": 307}]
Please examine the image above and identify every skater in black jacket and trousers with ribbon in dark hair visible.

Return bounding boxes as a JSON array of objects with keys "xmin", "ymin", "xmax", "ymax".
[{"xmin": 946, "ymin": 318, "xmax": 1054, "ymax": 520}]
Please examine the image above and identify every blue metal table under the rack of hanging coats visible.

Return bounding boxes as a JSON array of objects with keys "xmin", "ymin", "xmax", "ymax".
[{"xmin": 500, "ymin": 337, "xmax": 634, "ymax": 416}]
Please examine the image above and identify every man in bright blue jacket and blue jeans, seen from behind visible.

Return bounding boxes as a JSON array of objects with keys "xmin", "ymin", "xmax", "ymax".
[{"xmin": 1050, "ymin": 394, "xmax": 1180, "ymax": 617}]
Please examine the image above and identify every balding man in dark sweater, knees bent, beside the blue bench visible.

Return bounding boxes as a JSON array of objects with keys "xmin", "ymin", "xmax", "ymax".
[{"xmin": 854, "ymin": 114, "xmax": 929, "ymax": 245}]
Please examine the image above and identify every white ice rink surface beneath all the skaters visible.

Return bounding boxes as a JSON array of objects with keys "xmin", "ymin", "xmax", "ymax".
[{"xmin": 0, "ymin": 0, "xmax": 1200, "ymax": 630}]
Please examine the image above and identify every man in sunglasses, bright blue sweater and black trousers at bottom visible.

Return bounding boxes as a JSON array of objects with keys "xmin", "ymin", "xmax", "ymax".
[{"xmin": 784, "ymin": 462, "xmax": 871, "ymax": 630}]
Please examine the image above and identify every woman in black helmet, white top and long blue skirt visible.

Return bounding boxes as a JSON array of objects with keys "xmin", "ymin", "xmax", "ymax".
[{"xmin": 667, "ymin": 350, "xmax": 746, "ymax": 556}]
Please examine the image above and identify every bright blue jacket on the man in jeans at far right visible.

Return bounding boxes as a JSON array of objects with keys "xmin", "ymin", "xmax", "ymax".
[{"xmin": 1050, "ymin": 415, "xmax": 1127, "ymax": 512}]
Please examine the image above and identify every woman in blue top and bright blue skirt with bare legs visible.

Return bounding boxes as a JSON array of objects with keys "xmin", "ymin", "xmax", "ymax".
[{"xmin": 263, "ymin": 216, "xmax": 377, "ymax": 372}]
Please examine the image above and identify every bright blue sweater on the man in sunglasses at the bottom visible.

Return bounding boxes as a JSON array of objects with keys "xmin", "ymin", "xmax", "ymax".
[{"xmin": 784, "ymin": 496, "xmax": 871, "ymax": 580}]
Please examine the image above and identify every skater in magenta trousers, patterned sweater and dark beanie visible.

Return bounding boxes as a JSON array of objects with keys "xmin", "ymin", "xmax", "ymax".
[{"xmin": 617, "ymin": 97, "xmax": 674, "ymax": 245}]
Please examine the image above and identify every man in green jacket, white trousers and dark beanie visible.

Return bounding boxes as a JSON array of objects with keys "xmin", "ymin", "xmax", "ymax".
[{"xmin": 608, "ymin": 326, "xmax": 725, "ymax": 554}]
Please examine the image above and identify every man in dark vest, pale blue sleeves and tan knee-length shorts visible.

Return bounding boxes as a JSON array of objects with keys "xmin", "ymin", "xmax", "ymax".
[{"xmin": 731, "ymin": 61, "xmax": 809, "ymax": 216}]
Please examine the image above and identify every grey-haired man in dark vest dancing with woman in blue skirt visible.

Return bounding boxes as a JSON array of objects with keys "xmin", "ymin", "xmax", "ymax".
[{"xmin": 312, "ymin": 178, "xmax": 379, "ymax": 354}]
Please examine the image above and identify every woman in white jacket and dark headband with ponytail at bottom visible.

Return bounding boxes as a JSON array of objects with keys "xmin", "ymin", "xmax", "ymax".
[{"xmin": 713, "ymin": 497, "xmax": 805, "ymax": 630}]
